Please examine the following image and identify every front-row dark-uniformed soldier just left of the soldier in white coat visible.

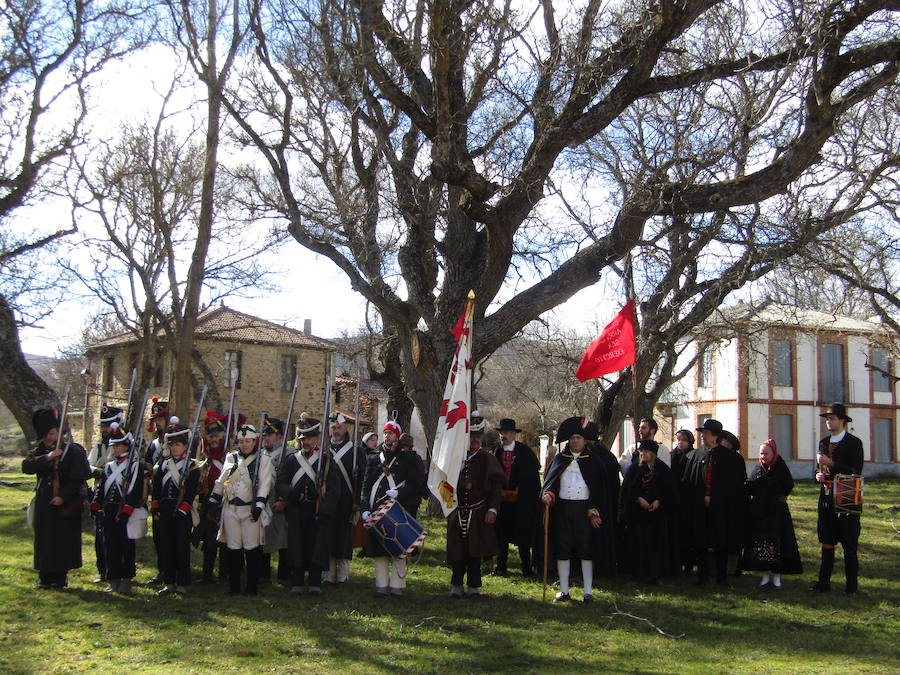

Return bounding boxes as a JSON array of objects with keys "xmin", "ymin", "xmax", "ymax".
[{"xmin": 150, "ymin": 424, "xmax": 200, "ymax": 595}]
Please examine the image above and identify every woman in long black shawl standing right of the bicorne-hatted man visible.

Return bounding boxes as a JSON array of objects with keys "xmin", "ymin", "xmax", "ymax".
[{"xmin": 619, "ymin": 440, "xmax": 675, "ymax": 584}]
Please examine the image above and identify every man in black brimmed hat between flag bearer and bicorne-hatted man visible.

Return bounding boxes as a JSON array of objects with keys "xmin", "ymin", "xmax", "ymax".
[{"xmin": 494, "ymin": 418, "xmax": 541, "ymax": 576}]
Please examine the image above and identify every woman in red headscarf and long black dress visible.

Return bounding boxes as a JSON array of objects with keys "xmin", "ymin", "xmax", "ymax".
[{"xmin": 743, "ymin": 438, "xmax": 803, "ymax": 588}]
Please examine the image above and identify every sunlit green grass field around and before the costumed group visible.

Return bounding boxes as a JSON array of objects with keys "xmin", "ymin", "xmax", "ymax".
[{"xmin": 0, "ymin": 474, "xmax": 900, "ymax": 673}]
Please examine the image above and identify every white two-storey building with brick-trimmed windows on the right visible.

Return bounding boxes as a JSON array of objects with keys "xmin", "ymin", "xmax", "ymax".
[{"xmin": 659, "ymin": 304, "xmax": 900, "ymax": 478}]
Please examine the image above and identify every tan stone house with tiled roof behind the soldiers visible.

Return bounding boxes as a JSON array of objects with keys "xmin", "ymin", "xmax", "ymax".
[{"xmin": 76, "ymin": 306, "xmax": 336, "ymax": 444}]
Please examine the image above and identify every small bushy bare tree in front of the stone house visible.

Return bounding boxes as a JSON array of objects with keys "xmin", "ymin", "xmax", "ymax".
[{"xmin": 65, "ymin": 78, "xmax": 271, "ymax": 418}]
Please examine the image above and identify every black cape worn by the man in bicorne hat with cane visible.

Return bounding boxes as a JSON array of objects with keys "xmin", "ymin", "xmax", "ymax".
[{"xmin": 542, "ymin": 445, "xmax": 618, "ymax": 576}]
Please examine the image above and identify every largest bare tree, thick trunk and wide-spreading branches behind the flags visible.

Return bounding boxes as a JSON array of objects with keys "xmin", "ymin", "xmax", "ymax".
[{"xmin": 213, "ymin": 0, "xmax": 900, "ymax": 452}]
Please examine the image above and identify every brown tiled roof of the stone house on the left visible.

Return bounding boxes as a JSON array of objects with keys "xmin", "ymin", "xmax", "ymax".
[{"xmin": 90, "ymin": 306, "xmax": 335, "ymax": 351}]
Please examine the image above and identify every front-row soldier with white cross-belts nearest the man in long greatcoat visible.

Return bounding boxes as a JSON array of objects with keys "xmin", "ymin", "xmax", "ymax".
[{"xmin": 91, "ymin": 422, "xmax": 145, "ymax": 595}]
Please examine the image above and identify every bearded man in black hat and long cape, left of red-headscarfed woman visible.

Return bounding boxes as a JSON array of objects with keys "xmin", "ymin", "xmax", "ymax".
[{"xmin": 684, "ymin": 419, "xmax": 747, "ymax": 587}]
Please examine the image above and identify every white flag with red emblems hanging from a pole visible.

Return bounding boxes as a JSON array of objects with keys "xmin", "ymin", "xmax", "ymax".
[{"xmin": 428, "ymin": 291, "xmax": 475, "ymax": 516}]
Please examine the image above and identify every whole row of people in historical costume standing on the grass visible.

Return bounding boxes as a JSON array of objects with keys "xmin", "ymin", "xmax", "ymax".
[{"xmin": 23, "ymin": 399, "xmax": 862, "ymax": 602}]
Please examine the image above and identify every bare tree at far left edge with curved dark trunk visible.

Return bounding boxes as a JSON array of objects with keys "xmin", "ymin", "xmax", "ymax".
[{"xmin": 0, "ymin": 0, "xmax": 143, "ymax": 434}]
